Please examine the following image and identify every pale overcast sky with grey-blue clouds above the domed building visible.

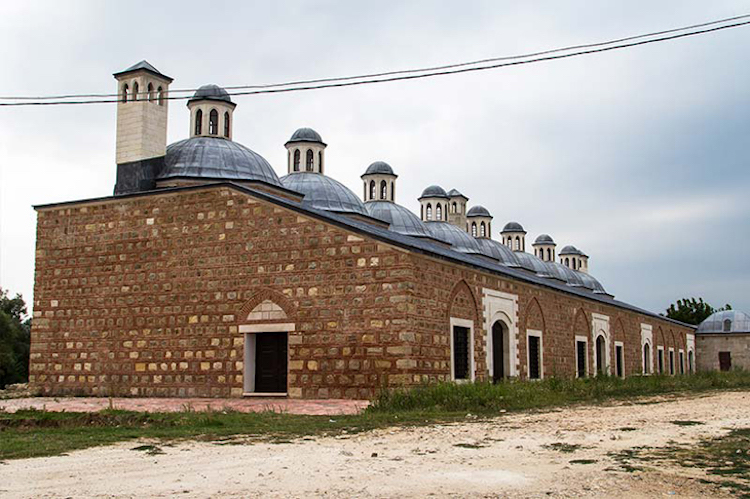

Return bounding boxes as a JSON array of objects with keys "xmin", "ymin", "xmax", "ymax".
[{"xmin": 0, "ymin": 0, "xmax": 750, "ymax": 312}]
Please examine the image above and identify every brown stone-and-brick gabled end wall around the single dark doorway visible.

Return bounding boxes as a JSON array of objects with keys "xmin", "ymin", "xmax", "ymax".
[{"xmin": 30, "ymin": 187, "xmax": 414, "ymax": 398}]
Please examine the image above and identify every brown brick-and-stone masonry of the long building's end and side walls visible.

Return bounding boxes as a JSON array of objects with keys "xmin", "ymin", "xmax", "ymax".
[{"xmin": 30, "ymin": 184, "xmax": 693, "ymax": 398}]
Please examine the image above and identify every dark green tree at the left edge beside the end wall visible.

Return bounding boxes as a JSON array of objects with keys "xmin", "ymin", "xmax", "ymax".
[{"xmin": 0, "ymin": 289, "xmax": 31, "ymax": 388}]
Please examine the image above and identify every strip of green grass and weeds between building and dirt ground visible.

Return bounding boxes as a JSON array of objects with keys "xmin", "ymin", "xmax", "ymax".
[{"xmin": 0, "ymin": 372, "xmax": 750, "ymax": 460}]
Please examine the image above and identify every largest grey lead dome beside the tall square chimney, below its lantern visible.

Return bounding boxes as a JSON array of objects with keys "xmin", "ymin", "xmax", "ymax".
[{"xmin": 162, "ymin": 137, "xmax": 281, "ymax": 186}]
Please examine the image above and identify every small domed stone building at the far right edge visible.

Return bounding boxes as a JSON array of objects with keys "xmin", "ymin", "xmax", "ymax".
[{"xmin": 690, "ymin": 310, "xmax": 750, "ymax": 371}]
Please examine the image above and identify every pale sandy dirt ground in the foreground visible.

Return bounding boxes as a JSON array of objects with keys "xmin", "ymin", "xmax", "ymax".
[{"xmin": 0, "ymin": 392, "xmax": 750, "ymax": 498}]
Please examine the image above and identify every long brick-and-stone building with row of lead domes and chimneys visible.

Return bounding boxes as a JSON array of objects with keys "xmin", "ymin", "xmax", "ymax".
[{"xmin": 30, "ymin": 61, "xmax": 694, "ymax": 398}]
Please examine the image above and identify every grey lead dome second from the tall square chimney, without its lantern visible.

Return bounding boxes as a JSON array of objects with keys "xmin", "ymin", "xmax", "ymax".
[{"xmin": 281, "ymin": 172, "xmax": 367, "ymax": 215}]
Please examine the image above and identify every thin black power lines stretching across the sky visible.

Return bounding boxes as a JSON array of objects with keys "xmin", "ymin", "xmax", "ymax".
[{"xmin": 0, "ymin": 14, "xmax": 750, "ymax": 107}]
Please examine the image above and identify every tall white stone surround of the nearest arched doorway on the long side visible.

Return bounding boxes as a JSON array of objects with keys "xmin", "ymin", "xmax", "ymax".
[{"xmin": 484, "ymin": 288, "xmax": 520, "ymax": 377}]
